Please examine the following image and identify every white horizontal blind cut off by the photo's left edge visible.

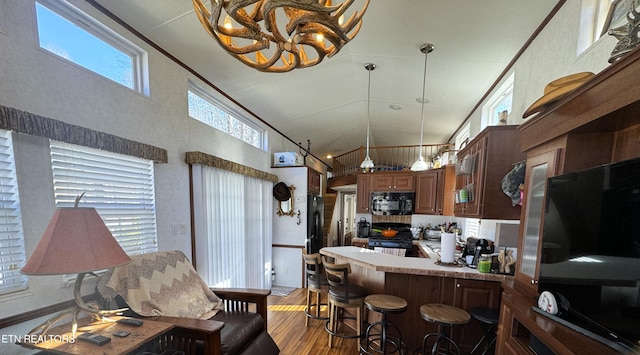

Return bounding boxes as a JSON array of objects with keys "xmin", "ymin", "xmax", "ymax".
[{"xmin": 0, "ymin": 130, "xmax": 27, "ymax": 294}]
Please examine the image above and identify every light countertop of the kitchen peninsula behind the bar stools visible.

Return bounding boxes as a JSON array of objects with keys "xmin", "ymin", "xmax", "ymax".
[{"xmin": 320, "ymin": 240, "xmax": 513, "ymax": 281}]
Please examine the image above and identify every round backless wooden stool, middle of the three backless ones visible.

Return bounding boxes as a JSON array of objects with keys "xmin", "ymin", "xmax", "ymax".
[{"xmin": 420, "ymin": 303, "xmax": 471, "ymax": 355}]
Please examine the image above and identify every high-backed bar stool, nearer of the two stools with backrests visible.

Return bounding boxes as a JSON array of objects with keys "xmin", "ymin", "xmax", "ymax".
[{"xmin": 323, "ymin": 258, "xmax": 368, "ymax": 347}]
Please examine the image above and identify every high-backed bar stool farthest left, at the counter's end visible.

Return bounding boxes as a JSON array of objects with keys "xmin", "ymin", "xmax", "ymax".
[{"xmin": 302, "ymin": 250, "xmax": 329, "ymax": 327}]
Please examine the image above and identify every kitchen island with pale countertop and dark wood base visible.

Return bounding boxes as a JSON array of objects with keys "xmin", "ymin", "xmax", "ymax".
[{"xmin": 320, "ymin": 246, "xmax": 511, "ymax": 353}]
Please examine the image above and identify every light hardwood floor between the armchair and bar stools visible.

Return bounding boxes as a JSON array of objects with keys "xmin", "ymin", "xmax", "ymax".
[{"xmin": 267, "ymin": 288, "xmax": 359, "ymax": 355}]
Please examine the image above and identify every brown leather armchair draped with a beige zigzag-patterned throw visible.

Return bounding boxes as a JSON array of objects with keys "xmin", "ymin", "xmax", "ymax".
[{"xmin": 97, "ymin": 251, "xmax": 280, "ymax": 355}]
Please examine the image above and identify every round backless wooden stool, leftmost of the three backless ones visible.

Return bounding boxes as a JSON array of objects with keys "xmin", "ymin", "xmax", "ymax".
[{"xmin": 360, "ymin": 294, "xmax": 408, "ymax": 355}]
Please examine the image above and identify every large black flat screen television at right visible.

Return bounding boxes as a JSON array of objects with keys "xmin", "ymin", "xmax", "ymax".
[{"xmin": 538, "ymin": 158, "xmax": 640, "ymax": 351}]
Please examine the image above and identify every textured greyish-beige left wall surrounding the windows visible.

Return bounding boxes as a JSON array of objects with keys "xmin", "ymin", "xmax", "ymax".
[{"xmin": 0, "ymin": 0, "xmax": 304, "ymax": 328}]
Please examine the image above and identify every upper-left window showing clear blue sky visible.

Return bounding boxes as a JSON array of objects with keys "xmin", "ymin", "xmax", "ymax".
[{"xmin": 36, "ymin": 0, "xmax": 148, "ymax": 95}]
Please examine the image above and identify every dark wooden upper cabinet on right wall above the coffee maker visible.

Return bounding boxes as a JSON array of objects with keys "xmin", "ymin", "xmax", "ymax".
[{"xmin": 454, "ymin": 125, "xmax": 525, "ymax": 219}]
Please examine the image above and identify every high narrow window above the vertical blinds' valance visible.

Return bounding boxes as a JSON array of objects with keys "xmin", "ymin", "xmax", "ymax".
[{"xmin": 187, "ymin": 83, "xmax": 265, "ymax": 150}]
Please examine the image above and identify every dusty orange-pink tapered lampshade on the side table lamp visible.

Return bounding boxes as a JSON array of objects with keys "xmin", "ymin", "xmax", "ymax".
[{"xmin": 21, "ymin": 207, "xmax": 131, "ymax": 275}]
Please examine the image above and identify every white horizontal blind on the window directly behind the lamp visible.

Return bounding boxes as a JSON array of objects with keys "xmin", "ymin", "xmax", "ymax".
[{"xmin": 50, "ymin": 141, "xmax": 158, "ymax": 255}]
